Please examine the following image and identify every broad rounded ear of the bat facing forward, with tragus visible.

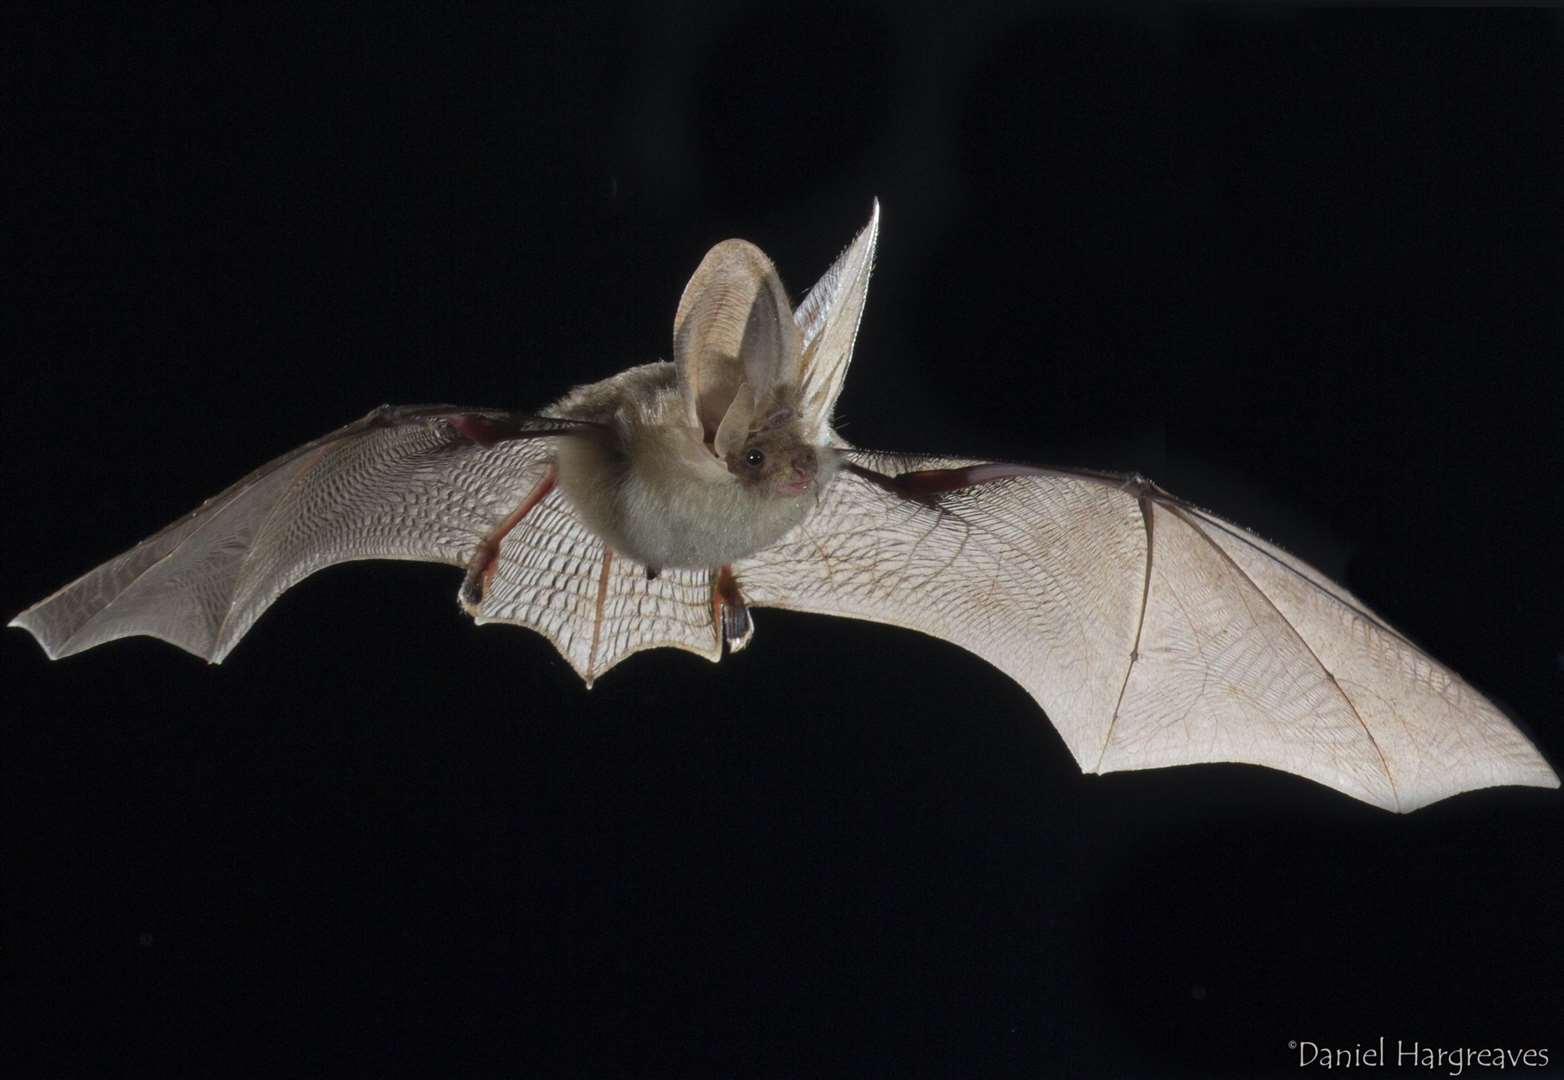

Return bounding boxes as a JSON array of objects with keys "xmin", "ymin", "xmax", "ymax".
[{"xmin": 674, "ymin": 241, "xmax": 801, "ymax": 439}]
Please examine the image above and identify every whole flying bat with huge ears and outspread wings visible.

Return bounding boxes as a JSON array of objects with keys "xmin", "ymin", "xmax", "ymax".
[{"xmin": 11, "ymin": 202, "xmax": 1559, "ymax": 813}]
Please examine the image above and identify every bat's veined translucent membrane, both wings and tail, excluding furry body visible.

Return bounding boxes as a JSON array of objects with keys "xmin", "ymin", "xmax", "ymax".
[{"xmin": 16, "ymin": 434, "xmax": 1558, "ymax": 811}]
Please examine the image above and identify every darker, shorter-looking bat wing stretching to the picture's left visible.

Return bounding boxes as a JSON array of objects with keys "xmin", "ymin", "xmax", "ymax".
[{"xmin": 11, "ymin": 405, "xmax": 572, "ymax": 663}]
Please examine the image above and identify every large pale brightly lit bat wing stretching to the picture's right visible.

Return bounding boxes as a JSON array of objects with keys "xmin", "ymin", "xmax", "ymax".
[{"xmin": 735, "ymin": 452, "xmax": 1559, "ymax": 811}]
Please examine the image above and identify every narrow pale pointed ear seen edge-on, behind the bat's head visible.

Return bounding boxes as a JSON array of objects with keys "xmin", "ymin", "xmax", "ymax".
[{"xmin": 793, "ymin": 198, "xmax": 879, "ymax": 442}]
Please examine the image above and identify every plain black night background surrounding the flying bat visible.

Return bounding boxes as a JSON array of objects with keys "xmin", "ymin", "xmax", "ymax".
[{"xmin": 0, "ymin": 3, "xmax": 1564, "ymax": 1077}]
